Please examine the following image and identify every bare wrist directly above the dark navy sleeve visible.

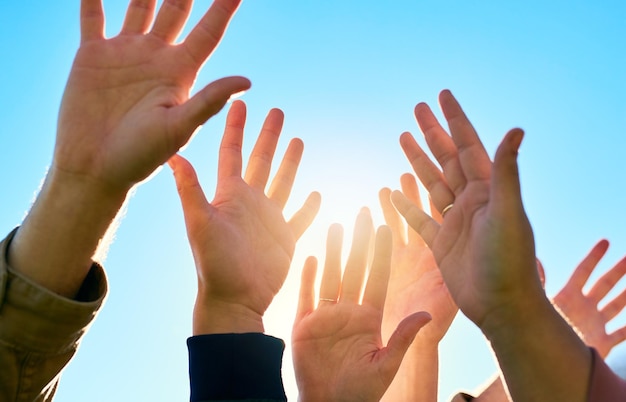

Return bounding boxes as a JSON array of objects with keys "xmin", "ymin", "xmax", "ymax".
[{"xmin": 193, "ymin": 295, "xmax": 265, "ymax": 336}]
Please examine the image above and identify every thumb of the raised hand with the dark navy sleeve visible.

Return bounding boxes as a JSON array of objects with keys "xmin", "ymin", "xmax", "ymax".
[{"xmin": 167, "ymin": 154, "xmax": 210, "ymax": 226}]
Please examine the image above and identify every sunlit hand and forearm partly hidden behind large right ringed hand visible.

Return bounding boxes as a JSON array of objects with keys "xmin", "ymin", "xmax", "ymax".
[{"xmin": 379, "ymin": 174, "xmax": 458, "ymax": 402}]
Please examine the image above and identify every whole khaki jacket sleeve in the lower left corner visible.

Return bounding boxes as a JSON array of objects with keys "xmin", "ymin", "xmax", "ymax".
[{"xmin": 0, "ymin": 229, "xmax": 107, "ymax": 402}]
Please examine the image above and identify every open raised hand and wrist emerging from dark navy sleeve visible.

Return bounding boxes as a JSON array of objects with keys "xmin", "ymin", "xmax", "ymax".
[{"xmin": 170, "ymin": 101, "xmax": 320, "ymax": 335}]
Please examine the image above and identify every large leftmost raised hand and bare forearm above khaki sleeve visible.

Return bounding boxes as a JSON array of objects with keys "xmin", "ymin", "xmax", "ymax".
[{"xmin": 9, "ymin": 0, "xmax": 250, "ymax": 297}]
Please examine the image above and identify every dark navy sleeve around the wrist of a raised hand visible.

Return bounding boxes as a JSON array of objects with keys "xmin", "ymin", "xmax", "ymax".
[{"xmin": 187, "ymin": 333, "xmax": 287, "ymax": 402}]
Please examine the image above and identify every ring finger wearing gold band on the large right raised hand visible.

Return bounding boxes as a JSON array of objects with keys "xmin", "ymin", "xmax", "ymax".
[{"xmin": 400, "ymin": 133, "xmax": 454, "ymax": 214}]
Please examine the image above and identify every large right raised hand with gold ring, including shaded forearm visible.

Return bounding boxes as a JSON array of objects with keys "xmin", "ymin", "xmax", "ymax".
[{"xmin": 392, "ymin": 91, "xmax": 591, "ymax": 401}]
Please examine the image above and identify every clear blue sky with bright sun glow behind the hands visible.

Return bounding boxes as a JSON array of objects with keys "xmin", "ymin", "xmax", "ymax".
[{"xmin": 0, "ymin": 0, "xmax": 626, "ymax": 402}]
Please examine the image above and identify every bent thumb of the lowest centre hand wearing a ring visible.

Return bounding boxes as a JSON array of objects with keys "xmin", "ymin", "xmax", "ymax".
[{"xmin": 381, "ymin": 311, "xmax": 432, "ymax": 384}]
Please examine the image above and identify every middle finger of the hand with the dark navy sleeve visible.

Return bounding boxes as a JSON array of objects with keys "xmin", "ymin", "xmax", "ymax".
[{"xmin": 244, "ymin": 109, "xmax": 284, "ymax": 191}]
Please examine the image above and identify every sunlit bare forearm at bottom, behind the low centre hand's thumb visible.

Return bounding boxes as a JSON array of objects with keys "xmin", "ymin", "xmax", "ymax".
[{"xmin": 382, "ymin": 340, "xmax": 439, "ymax": 402}]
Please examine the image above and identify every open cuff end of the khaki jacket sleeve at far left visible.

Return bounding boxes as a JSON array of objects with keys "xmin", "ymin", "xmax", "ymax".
[{"xmin": 0, "ymin": 229, "xmax": 107, "ymax": 354}]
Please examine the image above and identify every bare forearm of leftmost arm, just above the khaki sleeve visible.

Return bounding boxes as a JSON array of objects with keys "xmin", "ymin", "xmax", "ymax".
[{"xmin": 8, "ymin": 170, "xmax": 126, "ymax": 298}]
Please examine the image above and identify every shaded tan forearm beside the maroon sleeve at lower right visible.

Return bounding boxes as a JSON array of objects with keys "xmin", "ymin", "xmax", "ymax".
[{"xmin": 482, "ymin": 297, "xmax": 591, "ymax": 402}]
